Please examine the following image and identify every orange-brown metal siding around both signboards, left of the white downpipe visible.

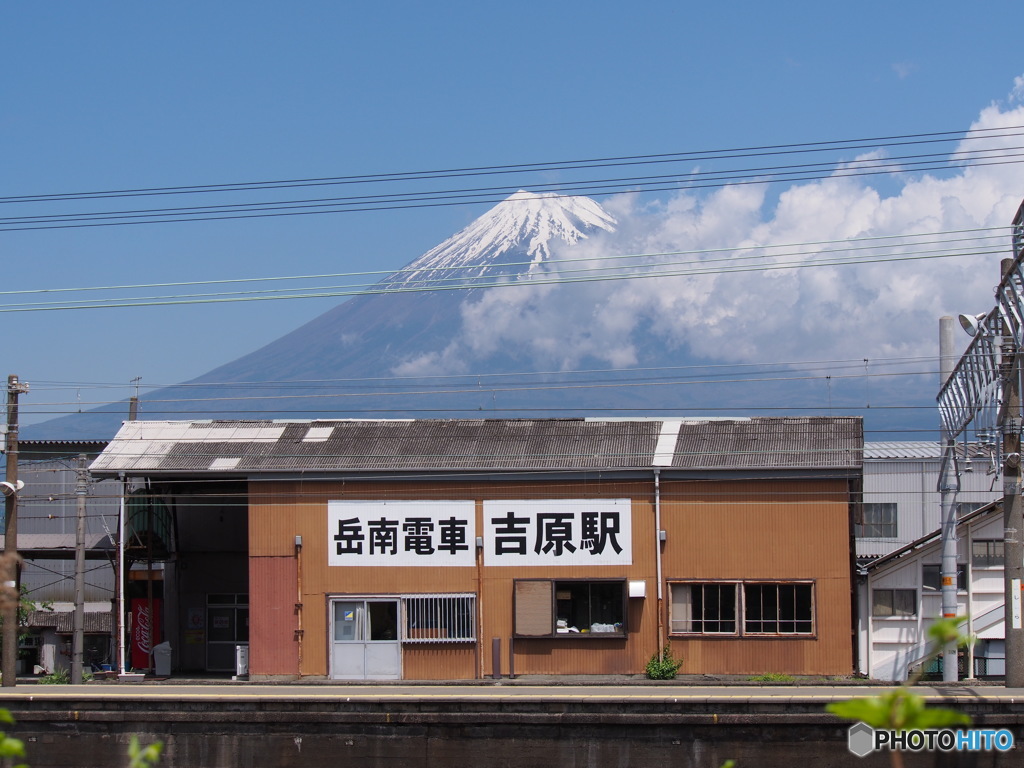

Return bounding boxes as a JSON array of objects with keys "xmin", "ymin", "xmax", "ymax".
[{"xmin": 250, "ymin": 479, "xmax": 657, "ymax": 675}]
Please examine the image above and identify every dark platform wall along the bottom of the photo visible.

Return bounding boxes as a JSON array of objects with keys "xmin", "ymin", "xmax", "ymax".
[{"xmin": 9, "ymin": 699, "xmax": 1024, "ymax": 768}]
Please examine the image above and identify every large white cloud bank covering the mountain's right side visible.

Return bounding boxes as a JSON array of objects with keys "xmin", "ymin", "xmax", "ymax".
[{"xmin": 399, "ymin": 78, "xmax": 1024, "ymax": 375}]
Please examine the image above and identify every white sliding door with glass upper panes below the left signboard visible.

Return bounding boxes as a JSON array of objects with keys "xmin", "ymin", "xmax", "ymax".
[{"xmin": 331, "ymin": 600, "xmax": 401, "ymax": 680}]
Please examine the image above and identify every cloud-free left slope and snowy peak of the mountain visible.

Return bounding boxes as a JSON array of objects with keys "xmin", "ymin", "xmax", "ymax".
[{"xmin": 32, "ymin": 190, "xmax": 663, "ymax": 439}]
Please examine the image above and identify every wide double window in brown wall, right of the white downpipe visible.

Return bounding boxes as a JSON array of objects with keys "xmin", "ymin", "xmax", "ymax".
[{"xmin": 670, "ymin": 582, "xmax": 814, "ymax": 636}]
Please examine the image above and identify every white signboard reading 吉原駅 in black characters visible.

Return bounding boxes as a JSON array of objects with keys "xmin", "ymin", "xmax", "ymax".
[{"xmin": 483, "ymin": 499, "xmax": 633, "ymax": 565}]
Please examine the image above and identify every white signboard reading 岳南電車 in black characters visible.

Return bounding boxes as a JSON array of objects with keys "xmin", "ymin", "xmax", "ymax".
[{"xmin": 327, "ymin": 501, "xmax": 476, "ymax": 566}]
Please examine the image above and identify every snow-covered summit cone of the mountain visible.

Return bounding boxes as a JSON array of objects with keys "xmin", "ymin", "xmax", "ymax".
[{"xmin": 387, "ymin": 189, "xmax": 615, "ymax": 286}]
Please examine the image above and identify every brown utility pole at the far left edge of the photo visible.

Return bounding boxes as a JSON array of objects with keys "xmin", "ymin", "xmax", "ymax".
[{"xmin": 0, "ymin": 375, "xmax": 29, "ymax": 688}]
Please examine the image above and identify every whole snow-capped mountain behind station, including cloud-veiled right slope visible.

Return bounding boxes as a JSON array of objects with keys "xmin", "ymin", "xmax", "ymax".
[{"xmin": 23, "ymin": 190, "xmax": 909, "ymax": 439}]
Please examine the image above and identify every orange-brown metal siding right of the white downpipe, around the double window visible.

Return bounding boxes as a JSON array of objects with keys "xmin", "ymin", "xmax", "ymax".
[{"xmin": 662, "ymin": 480, "xmax": 853, "ymax": 675}]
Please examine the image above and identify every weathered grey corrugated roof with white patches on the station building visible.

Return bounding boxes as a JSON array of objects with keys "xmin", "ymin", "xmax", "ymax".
[{"xmin": 91, "ymin": 417, "xmax": 863, "ymax": 475}]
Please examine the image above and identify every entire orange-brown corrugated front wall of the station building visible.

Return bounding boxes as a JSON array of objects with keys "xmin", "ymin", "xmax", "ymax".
[{"xmin": 249, "ymin": 479, "xmax": 852, "ymax": 679}]
